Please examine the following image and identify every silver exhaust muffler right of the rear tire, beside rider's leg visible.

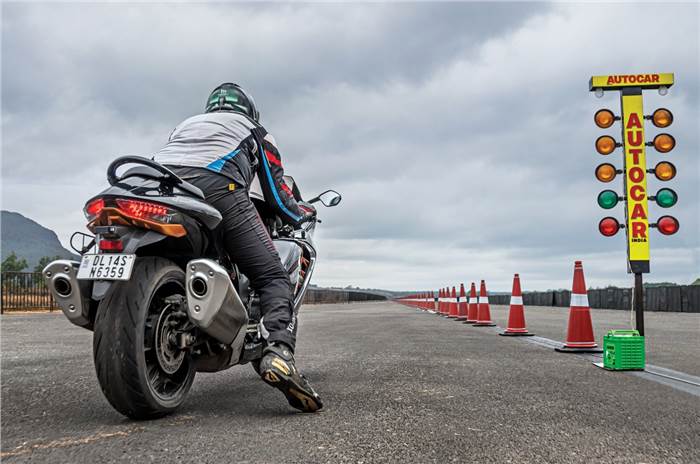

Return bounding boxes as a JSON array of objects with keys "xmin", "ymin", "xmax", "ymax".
[{"xmin": 186, "ymin": 259, "xmax": 248, "ymax": 348}]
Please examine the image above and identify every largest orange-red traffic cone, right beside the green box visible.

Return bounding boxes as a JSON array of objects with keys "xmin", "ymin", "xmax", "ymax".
[{"xmin": 554, "ymin": 261, "xmax": 603, "ymax": 353}]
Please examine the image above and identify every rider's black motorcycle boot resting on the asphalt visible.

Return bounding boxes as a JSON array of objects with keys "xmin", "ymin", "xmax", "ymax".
[{"xmin": 260, "ymin": 343, "xmax": 323, "ymax": 412}]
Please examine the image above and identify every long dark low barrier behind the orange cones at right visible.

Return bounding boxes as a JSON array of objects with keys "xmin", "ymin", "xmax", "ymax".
[{"xmin": 489, "ymin": 285, "xmax": 700, "ymax": 313}]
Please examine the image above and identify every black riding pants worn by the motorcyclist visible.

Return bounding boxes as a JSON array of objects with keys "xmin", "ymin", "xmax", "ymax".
[{"xmin": 172, "ymin": 167, "xmax": 296, "ymax": 351}]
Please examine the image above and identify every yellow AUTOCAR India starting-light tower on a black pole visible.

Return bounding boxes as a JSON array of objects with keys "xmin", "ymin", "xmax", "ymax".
[{"xmin": 589, "ymin": 73, "xmax": 679, "ymax": 335}]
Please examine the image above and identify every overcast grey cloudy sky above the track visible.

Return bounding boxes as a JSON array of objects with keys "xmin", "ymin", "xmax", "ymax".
[{"xmin": 0, "ymin": 2, "xmax": 700, "ymax": 290}]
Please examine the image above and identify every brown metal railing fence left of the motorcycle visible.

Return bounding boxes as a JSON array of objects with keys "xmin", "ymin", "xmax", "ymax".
[{"xmin": 0, "ymin": 272, "xmax": 58, "ymax": 313}]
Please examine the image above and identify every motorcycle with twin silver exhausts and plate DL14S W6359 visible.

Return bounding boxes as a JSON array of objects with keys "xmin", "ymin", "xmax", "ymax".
[{"xmin": 43, "ymin": 156, "xmax": 342, "ymax": 419}]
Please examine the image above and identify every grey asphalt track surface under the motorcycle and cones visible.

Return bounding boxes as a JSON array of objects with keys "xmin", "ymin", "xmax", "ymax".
[{"xmin": 1, "ymin": 302, "xmax": 700, "ymax": 463}]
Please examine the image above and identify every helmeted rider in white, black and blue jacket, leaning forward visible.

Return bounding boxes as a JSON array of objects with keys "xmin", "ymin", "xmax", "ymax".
[{"xmin": 153, "ymin": 83, "xmax": 323, "ymax": 412}]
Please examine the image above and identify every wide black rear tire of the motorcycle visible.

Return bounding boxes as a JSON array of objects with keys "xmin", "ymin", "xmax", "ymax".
[{"xmin": 93, "ymin": 257, "xmax": 196, "ymax": 419}]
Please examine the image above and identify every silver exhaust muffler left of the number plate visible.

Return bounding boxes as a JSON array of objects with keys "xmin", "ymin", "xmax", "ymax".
[{"xmin": 42, "ymin": 259, "xmax": 91, "ymax": 327}]
